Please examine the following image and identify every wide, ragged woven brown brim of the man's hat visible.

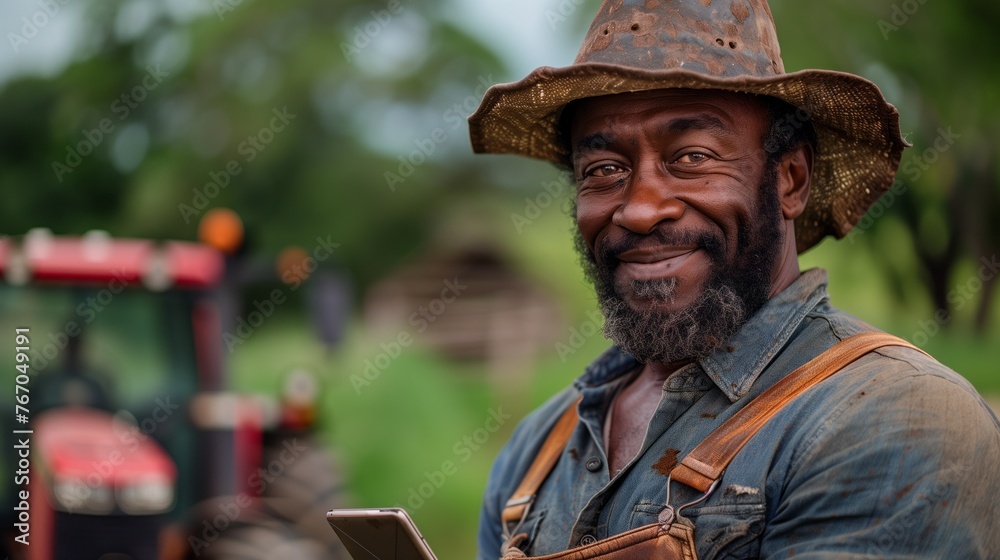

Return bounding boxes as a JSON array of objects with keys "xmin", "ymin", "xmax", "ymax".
[{"xmin": 469, "ymin": 63, "xmax": 908, "ymax": 253}]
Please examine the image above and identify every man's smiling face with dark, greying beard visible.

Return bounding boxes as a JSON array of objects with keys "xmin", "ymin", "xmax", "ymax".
[{"xmin": 569, "ymin": 90, "xmax": 797, "ymax": 363}]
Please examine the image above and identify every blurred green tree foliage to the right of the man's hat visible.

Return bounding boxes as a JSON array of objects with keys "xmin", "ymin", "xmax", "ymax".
[{"xmin": 772, "ymin": 0, "xmax": 1000, "ymax": 332}]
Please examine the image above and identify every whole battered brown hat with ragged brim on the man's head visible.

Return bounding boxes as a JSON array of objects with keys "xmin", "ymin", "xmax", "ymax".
[{"xmin": 469, "ymin": 0, "xmax": 908, "ymax": 253}]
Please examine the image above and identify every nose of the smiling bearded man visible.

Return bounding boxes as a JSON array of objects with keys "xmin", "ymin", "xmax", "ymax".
[{"xmin": 611, "ymin": 166, "xmax": 685, "ymax": 234}]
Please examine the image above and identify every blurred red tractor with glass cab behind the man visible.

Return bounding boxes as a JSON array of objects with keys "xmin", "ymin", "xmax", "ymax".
[{"xmin": 0, "ymin": 226, "xmax": 348, "ymax": 560}]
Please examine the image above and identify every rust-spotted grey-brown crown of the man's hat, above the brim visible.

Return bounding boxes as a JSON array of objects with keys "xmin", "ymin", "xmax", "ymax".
[{"xmin": 575, "ymin": 0, "xmax": 785, "ymax": 77}]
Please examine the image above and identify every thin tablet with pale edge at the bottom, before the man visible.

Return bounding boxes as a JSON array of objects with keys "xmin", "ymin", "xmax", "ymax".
[{"xmin": 326, "ymin": 508, "xmax": 437, "ymax": 560}]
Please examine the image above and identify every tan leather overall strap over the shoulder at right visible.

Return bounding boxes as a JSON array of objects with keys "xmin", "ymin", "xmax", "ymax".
[{"xmin": 671, "ymin": 332, "xmax": 923, "ymax": 492}]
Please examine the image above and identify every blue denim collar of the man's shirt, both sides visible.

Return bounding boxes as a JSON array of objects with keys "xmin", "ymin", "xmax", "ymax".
[{"xmin": 574, "ymin": 269, "xmax": 829, "ymax": 402}]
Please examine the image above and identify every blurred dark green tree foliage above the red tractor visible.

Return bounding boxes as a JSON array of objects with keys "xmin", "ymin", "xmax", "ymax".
[{"xmin": 0, "ymin": 0, "xmax": 502, "ymax": 284}]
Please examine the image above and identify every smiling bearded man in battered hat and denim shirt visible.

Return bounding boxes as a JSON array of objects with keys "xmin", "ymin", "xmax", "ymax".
[{"xmin": 470, "ymin": 0, "xmax": 1000, "ymax": 560}]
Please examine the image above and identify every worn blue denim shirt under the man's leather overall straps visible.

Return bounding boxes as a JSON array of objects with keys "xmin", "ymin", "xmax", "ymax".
[{"xmin": 478, "ymin": 270, "xmax": 1000, "ymax": 560}]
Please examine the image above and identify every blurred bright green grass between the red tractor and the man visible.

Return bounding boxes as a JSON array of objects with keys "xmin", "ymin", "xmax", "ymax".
[{"xmin": 233, "ymin": 318, "xmax": 603, "ymax": 558}]
